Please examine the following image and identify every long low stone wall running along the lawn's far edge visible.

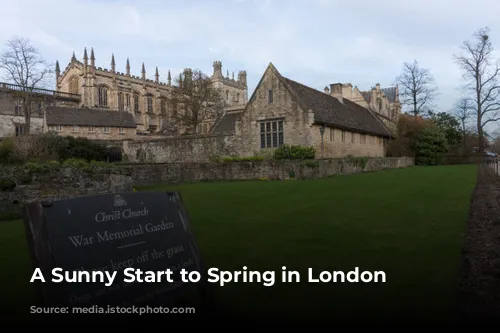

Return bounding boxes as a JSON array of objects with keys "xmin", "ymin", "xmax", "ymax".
[{"xmin": 0, "ymin": 157, "xmax": 414, "ymax": 219}]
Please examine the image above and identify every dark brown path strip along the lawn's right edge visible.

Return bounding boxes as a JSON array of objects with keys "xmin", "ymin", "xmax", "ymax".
[{"xmin": 459, "ymin": 164, "xmax": 500, "ymax": 323}]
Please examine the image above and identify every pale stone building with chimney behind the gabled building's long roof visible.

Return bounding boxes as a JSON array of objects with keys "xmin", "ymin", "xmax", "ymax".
[{"xmin": 324, "ymin": 83, "xmax": 401, "ymax": 131}]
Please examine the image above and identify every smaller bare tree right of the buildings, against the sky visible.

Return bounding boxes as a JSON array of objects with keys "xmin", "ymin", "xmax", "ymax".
[{"xmin": 396, "ymin": 60, "xmax": 437, "ymax": 116}]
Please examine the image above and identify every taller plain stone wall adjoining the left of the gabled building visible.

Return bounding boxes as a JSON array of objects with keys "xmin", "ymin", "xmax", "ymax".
[{"xmin": 123, "ymin": 134, "xmax": 237, "ymax": 163}]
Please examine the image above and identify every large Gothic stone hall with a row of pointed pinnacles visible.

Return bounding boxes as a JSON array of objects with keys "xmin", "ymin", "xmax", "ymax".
[{"xmin": 56, "ymin": 48, "xmax": 248, "ymax": 136}]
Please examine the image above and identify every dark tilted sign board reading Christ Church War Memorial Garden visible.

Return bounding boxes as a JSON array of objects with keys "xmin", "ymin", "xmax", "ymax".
[{"xmin": 25, "ymin": 192, "xmax": 205, "ymax": 315}]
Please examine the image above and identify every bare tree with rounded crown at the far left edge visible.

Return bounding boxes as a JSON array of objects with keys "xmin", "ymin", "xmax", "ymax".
[{"xmin": 0, "ymin": 37, "xmax": 52, "ymax": 134}]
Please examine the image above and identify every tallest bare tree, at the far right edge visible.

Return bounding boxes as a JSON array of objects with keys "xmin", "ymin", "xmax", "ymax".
[{"xmin": 455, "ymin": 27, "xmax": 500, "ymax": 151}]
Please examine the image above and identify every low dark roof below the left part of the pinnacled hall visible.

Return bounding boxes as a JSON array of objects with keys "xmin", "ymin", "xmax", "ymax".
[{"xmin": 46, "ymin": 107, "xmax": 137, "ymax": 128}]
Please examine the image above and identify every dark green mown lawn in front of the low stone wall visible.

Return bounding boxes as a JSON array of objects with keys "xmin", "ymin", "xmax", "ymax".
[{"xmin": 0, "ymin": 165, "xmax": 476, "ymax": 320}]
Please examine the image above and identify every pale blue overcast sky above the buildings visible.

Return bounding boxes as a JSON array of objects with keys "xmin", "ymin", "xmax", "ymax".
[{"xmin": 0, "ymin": 0, "xmax": 500, "ymax": 130}]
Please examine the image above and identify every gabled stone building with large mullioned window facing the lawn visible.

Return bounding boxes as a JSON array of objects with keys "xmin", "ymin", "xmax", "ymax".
[{"xmin": 214, "ymin": 64, "xmax": 391, "ymax": 158}]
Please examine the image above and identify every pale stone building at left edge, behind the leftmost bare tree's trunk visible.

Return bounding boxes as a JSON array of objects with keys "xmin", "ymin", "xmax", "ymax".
[{"xmin": 0, "ymin": 83, "xmax": 80, "ymax": 138}]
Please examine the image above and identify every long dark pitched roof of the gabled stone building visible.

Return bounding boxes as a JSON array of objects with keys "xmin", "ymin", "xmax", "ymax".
[{"xmin": 276, "ymin": 71, "xmax": 391, "ymax": 137}]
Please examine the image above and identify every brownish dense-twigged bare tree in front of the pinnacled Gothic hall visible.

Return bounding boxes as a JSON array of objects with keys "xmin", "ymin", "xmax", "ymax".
[{"xmin": 169, "ymin": 69, "xmax": 222, "ymax": 134}]
